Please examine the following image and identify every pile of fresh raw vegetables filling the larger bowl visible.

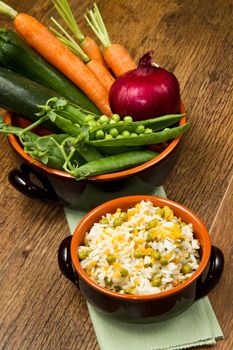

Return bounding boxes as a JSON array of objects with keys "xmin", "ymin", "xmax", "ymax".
[{"xmin": 0, "ymin": 0, "xmax": 189, "ymax": 180}]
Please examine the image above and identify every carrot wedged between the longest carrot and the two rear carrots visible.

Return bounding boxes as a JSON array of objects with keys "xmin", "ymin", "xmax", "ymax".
[{"xmin": 50, "ymin": 17, "xmax": 115, "ymax": 92}]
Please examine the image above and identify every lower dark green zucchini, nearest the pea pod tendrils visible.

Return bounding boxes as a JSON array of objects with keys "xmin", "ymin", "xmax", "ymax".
[{"xmin": 0, "ymin": 67, "xmax": 60, "ymax": 132}]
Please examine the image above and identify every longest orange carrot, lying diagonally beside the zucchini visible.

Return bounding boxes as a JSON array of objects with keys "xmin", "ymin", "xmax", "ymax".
[{"xmin": 0, "ymin": 2, "xmax": 112, "ymax": 115}]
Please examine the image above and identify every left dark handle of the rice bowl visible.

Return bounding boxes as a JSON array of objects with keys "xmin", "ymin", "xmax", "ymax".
[{"xmin": 58, "ymin": 236, "xmax": 79, "ymax": 288}]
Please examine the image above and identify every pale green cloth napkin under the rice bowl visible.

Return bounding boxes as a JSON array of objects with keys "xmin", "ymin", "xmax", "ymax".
[{"xmin": 65, "ymin": 180, "xmax": 223, "ymax": 350}]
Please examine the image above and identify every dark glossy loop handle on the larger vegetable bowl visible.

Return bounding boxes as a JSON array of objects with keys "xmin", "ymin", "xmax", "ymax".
[{"xmin": 8, "ymin": 163, "xmax": 65, "ymax": 205}]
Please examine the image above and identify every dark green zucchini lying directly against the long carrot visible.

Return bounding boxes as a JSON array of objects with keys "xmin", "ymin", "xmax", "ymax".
[{"xmin": 0, "ymin": 28, "xmax": 101, "ymax": 115}]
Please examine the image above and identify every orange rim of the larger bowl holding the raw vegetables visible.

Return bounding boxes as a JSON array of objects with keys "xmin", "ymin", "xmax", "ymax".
[{"xmin": 4, "ymin": 103, "xmax": 187, "ymax": 181}]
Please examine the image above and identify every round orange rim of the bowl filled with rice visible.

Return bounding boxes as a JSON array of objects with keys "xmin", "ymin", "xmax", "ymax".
[{"xmin": 70, "ymin": 195, "xmax": 211, "ymax": 301}]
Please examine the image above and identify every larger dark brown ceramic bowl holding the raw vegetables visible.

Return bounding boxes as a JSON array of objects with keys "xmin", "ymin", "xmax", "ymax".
[{"xmin": 5, "ymin": 105, "xmax": 186, "ymax": 207}]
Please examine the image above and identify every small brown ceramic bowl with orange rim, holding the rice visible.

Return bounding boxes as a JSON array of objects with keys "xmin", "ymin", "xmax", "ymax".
[{"xmin": 58, "ymin": 195, "xmax": 224, "ymax": 322}]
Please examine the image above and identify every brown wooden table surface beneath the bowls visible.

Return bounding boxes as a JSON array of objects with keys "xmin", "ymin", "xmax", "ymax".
[{"xmin": 0, "ymin": 0, "xmax": 233, "ymax": 350}]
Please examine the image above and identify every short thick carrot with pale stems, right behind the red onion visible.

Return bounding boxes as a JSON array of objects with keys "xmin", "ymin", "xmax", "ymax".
[{"xmin": 85, "ymin": 4, "xmax": 136, "ymax": 77}]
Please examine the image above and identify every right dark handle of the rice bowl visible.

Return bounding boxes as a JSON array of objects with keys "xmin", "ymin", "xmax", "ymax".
[{"xmin": 196, "ymin": 245, "xmax": 224, "ymax": 299}]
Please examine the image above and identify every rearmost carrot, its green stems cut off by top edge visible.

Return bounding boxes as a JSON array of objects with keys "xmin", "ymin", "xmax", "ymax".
[{"xmin": 54, "ymin": 0, "xmax": 107, "ymax": 68}]
